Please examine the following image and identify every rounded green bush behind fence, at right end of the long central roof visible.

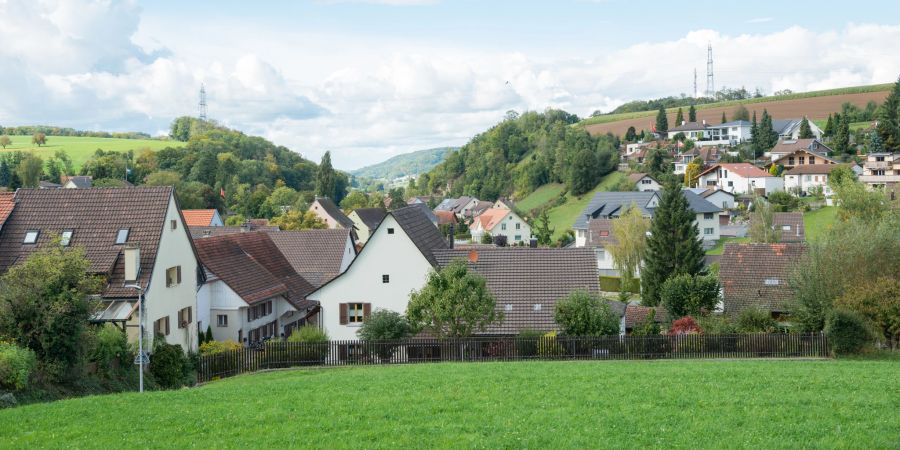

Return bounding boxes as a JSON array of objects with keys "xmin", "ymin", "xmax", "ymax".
[{"xmin": 554, "ymin": 290, "xmax": 619, "ymax": 336}]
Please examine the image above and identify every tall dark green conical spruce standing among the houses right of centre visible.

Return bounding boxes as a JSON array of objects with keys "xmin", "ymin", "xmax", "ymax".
[{"xmin": 641, "ymin": 179, "xmax": 704, "ymax": 306}]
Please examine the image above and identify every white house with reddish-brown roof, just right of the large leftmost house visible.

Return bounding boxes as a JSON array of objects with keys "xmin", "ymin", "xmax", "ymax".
[{"xmin": 196, "ymin": 232, "xmax": 317, "ymax": 343}]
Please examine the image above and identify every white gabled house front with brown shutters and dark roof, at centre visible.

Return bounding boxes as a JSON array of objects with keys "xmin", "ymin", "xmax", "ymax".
[{"xmin": 307, "ymin": 207, "xmax": 447, "ymax": 339}]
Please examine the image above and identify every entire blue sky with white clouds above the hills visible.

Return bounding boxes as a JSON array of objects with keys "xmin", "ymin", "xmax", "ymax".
[{"xmin": 0, "ymin": 0, "xmax": 900, "ymax": 170}]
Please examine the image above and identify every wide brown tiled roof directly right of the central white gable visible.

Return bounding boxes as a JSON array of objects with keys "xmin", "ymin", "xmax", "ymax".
[{"xmin": 435, "ymin": 247, "xmax": 600, "ymax": 334}]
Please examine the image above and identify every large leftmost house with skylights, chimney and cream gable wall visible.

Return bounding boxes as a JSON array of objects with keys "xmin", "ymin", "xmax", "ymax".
[{"xmin": 0, "ymin": 187, "xmax": 203, "ymax": 351}]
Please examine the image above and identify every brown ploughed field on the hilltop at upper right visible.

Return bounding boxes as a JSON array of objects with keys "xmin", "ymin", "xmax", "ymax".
[{"xmin": 580, "ymin": 83, "xmax": 893, "ymax": 136}]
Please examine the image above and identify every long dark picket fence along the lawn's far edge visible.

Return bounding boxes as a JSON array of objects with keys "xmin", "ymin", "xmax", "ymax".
[{"xmin": 198, "ymin": 333, "xmax": 828, "ymax": 382}]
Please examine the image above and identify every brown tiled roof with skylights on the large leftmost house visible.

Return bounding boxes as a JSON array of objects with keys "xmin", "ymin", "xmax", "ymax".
[{"xmin": 0, "ymin": 186, "xmax": 179, "ymax": 298}]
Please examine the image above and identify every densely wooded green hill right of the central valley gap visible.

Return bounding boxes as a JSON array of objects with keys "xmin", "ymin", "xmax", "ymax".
[{"xmin": 416, "ymin": 109, "xmax": 619, "ymax": 200}]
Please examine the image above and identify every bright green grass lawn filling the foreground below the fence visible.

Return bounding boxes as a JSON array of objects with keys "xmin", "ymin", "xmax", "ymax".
[{"xmin": 0, "ymin": 360, "xmax": 900, "ymax": 448}]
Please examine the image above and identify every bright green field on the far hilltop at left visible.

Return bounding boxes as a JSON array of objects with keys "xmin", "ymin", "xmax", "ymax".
[{"xmin": 0, "ymin": 136, "xmax": 185, "ymax": 170}]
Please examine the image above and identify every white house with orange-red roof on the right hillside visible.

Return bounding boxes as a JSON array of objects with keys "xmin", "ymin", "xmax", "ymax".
[{"xmin": 697, "ymin": 163, "xmax": 784, "ymax": 195}]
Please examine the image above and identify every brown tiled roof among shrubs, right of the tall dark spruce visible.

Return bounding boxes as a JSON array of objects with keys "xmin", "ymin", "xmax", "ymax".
[{"xmin": 719, "ymin": 243, "xmax": 806, "ymax": 316}]
